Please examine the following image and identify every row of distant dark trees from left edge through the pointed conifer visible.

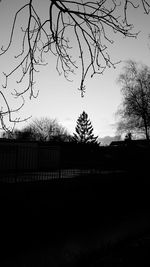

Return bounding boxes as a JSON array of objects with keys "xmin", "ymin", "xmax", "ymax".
[{"xmin": 2, "ymin": 111, "xmax": 98, "ymax": 145}]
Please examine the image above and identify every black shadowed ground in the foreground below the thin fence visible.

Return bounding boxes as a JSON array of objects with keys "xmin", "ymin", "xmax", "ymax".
[{"xmin": 0, "ymin": 172, "xmax": 150, "ymax": 267}]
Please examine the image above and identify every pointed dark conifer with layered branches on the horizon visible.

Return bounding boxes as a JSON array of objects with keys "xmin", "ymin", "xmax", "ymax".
[{"xmin": 73, "ymin": 111, "xmax": 98, "ymax": 144}]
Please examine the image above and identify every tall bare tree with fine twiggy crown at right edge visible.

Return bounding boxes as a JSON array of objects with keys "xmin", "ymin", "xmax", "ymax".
[{"xmin": 118, "ymin": 60, "xmax": 150, "ymax": 139}]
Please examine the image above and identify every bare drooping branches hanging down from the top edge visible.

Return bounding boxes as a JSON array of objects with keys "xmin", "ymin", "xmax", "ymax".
[{"xmin": 0, "ymin": 0, "xmax": 150, "ymax": 130}]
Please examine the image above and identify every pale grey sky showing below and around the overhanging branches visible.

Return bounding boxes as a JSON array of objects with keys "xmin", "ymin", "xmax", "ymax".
[{"xmin": 0, "ymin": 0, "xmax": 150, "ymax": 137}]
